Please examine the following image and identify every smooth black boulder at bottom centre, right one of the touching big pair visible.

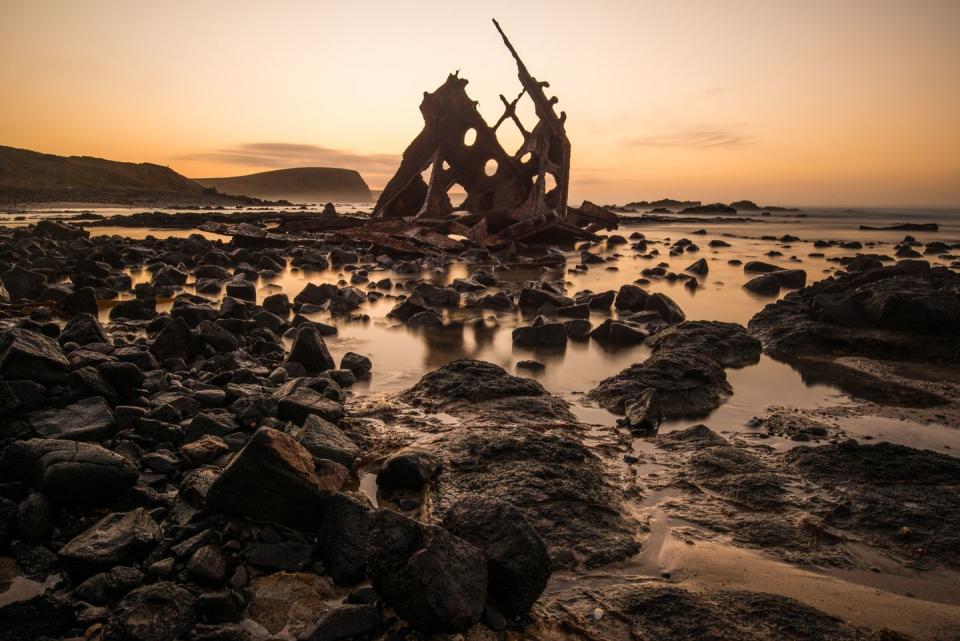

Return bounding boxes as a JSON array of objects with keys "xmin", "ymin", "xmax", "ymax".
[{"xmin": 443, "ymin": 497, "xmax": 550, "ymax": 617}]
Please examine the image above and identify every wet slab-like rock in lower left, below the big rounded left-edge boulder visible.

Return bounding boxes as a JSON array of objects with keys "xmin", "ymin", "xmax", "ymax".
[{"xmin": 58, "ymin": 508, "xmax": 162, "ymax": 578}]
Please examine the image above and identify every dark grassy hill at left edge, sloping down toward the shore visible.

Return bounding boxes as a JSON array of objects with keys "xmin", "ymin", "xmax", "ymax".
[{"xmin": 0, "ymin": 146, "xmax": 251, "ymax": 204}]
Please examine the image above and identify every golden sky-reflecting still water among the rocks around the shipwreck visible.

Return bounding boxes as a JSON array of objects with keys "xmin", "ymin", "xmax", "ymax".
[{"xmin": 67, "ymin": 212, "xmax": 960, "ymax": 430}]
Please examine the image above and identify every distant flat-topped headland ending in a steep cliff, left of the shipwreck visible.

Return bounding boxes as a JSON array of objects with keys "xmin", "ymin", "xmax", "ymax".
[{"xmin": 194, "ymin": 167, "xmax": 373, "ymax": 202}]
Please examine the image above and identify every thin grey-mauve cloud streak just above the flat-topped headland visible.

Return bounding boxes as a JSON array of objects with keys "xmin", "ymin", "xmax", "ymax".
[{"xmin": 180, "ymin": 142, "xmax": 400, "ymax": 176}]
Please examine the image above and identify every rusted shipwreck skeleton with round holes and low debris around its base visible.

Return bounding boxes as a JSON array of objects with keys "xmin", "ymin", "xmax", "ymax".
[{"xmin": 203, "ymin": 20, "xmax": 618, "ymax": 253}]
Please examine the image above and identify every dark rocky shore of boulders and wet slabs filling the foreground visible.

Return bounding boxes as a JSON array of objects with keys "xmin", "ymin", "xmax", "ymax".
[{"xmin": 0, "ymin": 221, "xmax": 960, "ymax": 641}]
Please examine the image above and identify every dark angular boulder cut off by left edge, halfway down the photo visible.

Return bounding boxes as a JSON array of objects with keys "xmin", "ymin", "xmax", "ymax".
[{"xmin": 0, "ymin": 328, "xmax": 70, "ymax": 385}]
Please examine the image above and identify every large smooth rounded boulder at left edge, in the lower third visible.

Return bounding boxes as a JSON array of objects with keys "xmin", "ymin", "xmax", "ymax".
[{"xmin": 0, "ymin": 439, "xmax": 139, "ymax": 506}]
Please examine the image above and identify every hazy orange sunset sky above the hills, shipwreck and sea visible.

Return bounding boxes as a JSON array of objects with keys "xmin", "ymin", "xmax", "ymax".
[{"xmin": 0, "ymin": 0, "xmax": 960, "ymax": 206}]
